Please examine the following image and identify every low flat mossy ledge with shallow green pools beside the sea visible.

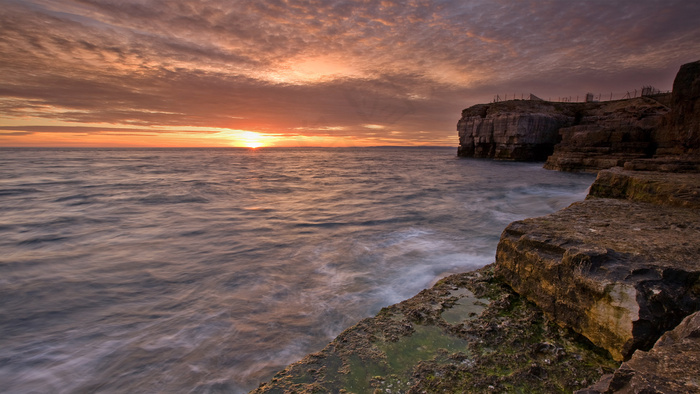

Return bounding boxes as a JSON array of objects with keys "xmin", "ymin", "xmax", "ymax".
[{"xmin": 253, "ymin": 266, "xmax": 619, "ymax": 393}]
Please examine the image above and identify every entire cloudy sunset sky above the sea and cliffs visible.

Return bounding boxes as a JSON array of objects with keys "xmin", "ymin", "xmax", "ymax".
[{"xmin": 0, "ymin": 0, "xmax": 700, "ymax": 147}]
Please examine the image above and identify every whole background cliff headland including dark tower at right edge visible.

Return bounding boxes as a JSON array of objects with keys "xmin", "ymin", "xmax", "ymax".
[{"xmin": 457, "ymin": 61, "xmax": 700, "ymax": 172}]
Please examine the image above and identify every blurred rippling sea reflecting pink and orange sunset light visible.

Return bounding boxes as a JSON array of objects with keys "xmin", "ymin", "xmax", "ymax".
[{"xmin": 0, "ymin": 148, "xmax": 594, "ymax": 393}]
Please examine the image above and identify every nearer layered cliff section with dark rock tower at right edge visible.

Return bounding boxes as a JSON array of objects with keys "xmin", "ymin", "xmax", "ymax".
[{"xmin": 545, "ymin": 61, "xmax": 700, "ymax": 172}]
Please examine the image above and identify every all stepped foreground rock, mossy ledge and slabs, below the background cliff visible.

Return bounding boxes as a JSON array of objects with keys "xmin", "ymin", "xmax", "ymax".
[{"xmin": 253, "ymin": 168, "xmax": 700, "ymax": 394}]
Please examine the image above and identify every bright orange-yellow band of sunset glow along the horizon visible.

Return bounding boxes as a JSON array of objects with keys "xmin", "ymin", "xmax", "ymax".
[{"xmin": 0, "ymin": 118, "xmax": 450, "ymax": 149}]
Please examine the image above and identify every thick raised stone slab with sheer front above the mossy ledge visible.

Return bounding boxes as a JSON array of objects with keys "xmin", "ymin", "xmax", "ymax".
[{"xmin": 496, "ymin": 198, "xmax": 700, "ymax": 361}]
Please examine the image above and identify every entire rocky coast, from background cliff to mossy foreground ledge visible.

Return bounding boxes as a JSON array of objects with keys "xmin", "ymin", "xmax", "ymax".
[{"xmin": 254, "ymin": 62, "xmax": 700, "ymax": 394}]
